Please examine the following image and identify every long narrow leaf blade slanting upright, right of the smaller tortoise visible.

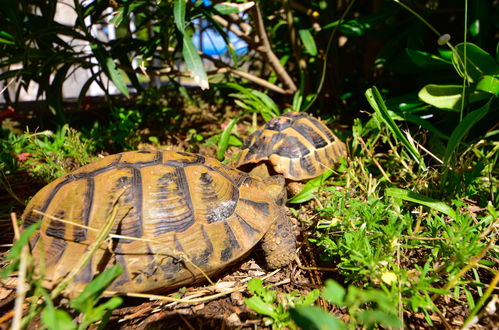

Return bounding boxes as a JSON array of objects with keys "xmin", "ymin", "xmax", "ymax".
[{"xmin": 365, "ymin": 86, "xmax": 426, "ymax": 169}]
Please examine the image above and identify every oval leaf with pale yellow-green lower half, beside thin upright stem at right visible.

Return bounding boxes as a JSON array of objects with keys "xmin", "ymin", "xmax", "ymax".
[{"xmin": 418, "ymin": 84, "xmax": 489, "ymax": 111}]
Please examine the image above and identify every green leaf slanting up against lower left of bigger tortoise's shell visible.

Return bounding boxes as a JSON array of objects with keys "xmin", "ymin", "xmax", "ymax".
[{"xmin": 69, "ymin": 264, "xmax": 123, "ymax": 312}]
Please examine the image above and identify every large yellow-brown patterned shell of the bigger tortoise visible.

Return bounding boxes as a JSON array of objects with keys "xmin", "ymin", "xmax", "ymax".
[{"xmin": 23, "ymin": 151, "xmax": 280, "ymax": 292}]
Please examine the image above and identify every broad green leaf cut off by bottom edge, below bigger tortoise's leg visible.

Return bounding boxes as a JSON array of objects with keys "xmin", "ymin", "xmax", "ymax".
[{"xmin": 289, "ymin": 306, "xmax": 347, "ymax": 330}]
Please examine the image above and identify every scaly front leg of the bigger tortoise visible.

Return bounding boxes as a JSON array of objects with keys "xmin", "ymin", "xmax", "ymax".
[{"xmin": 262, "ymin": 208, "xmax": 296, "ymax": 269}]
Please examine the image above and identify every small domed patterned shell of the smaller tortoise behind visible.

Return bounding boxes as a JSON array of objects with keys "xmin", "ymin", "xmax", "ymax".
[{"xmin": 236, "ymin": 112, "xmax": 346, "ymax": 181}]
